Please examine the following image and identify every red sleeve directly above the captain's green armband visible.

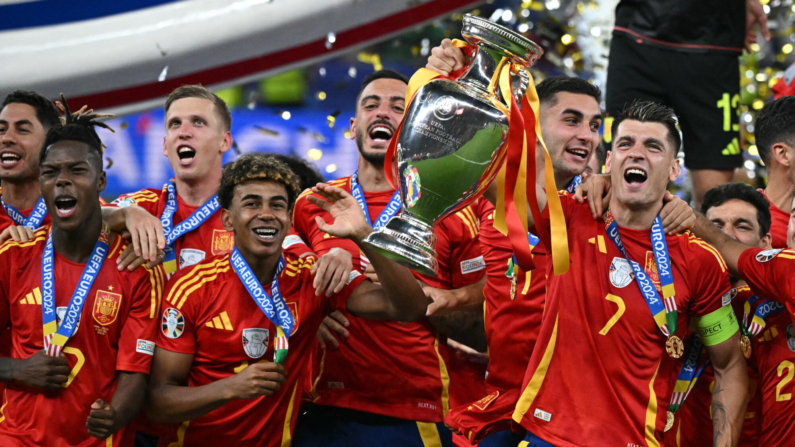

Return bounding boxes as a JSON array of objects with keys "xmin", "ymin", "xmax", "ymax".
[{"xmin": 681, "ymin": 238, "xmax": 731, "ymax": 317}]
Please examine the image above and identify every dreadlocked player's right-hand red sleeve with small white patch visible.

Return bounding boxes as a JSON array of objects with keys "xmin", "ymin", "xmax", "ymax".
[{"xmin": 116, "ymin": 266, "xmax": 166, "ymax": 374}]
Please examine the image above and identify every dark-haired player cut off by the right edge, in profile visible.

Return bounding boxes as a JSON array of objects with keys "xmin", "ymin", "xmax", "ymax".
[{"xmin": 754, "ymin": 96, "xmax": 795, "ymax": 248}]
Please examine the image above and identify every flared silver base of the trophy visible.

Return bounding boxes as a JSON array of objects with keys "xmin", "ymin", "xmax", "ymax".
[{"xmin": 364, "ymin": 213, "xmax": 438, "ymax": 277}]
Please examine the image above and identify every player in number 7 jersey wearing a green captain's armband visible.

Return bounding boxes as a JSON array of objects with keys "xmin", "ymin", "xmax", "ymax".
[{"xmin": 504, "ymin": 102, "xmax": 748, "ymax": 447}]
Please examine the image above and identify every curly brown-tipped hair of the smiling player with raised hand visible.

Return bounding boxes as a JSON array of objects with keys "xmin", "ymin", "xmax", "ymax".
[{"xmin": 218, "ymin": 154, "xmax": 301, "ymax": 210}]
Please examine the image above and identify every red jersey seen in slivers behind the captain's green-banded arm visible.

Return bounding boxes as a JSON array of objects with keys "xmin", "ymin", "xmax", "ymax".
[{"xmin": 665, "ymin": 286, "xmax": 764, "ymax": 447}]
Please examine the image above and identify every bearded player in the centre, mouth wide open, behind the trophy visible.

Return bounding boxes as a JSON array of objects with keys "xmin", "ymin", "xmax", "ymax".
[{"xmin": 293, "ymin": 70, "xmax": 484, "ymax": 446}]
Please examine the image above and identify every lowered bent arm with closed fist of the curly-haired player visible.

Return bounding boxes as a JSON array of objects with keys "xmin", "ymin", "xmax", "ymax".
[{"xmin": 146, "ymin": 348, "xmax": 287, "ymax": 423}]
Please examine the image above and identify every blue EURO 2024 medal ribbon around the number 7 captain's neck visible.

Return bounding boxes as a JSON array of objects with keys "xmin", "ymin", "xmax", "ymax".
[{"xmin": 603, "ymin": 210, "xmax": 678, "ymax": 337}]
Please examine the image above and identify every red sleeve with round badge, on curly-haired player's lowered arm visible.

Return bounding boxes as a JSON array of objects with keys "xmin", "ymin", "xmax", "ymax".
[{"xmin": 157, "ymin": 263, "xmax": 199, "ymax": 354}]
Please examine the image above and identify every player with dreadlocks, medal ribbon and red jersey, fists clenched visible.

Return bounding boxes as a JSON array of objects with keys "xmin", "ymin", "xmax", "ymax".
[{"xmin": 0, "ymin": 96, "xmax": 165, "ymax": 446}]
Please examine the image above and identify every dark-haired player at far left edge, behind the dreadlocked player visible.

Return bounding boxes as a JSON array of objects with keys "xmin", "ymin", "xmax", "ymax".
[{"xmin": 0, "ymin": 90, "xmax": 60, "ymax": 231}]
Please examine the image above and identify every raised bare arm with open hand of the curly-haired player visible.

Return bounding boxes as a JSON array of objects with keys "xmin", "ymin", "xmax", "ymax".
[{"xmin": 307, "ymin": 183, "xmax": 430, "ymax": 321}]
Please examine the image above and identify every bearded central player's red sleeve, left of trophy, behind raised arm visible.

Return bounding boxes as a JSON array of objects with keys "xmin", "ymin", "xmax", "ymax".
[{"xmin": 293, "ymin": 192, "xmax": 360, "ymax": 260}]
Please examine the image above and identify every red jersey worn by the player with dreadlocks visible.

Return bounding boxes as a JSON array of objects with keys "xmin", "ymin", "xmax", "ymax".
[{"xmin": 0, "ymin": 229, "xmax": 165, "ymax": 447}]
